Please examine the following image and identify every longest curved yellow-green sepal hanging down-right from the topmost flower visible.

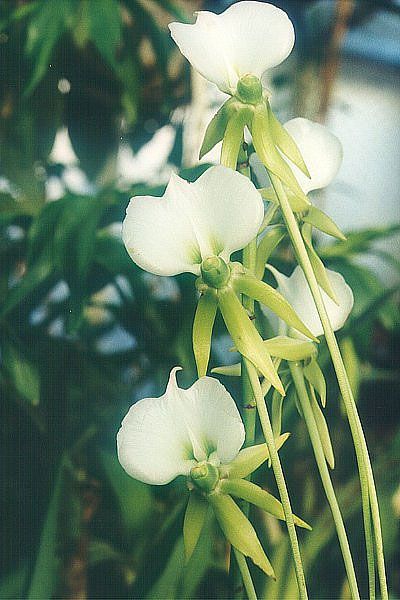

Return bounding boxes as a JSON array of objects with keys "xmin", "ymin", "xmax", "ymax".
[{"xmin": 250, "ymin": 103, "xmax": 309, "ymax": 204}]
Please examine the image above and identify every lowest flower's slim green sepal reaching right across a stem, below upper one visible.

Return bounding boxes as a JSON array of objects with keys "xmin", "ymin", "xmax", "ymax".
[{"xmin": 220, "ymin": 479, "xmax": 311, "ymax": 530}]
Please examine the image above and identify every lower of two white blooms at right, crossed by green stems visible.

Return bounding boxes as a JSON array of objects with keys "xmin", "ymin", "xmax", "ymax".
[{"xmin": 263, "ymin": 265, "xmax": 354, "ymax": 339}]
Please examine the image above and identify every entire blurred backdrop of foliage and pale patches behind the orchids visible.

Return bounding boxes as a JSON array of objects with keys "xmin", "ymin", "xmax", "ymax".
[{"xmin": 0, "ymin": 0, "xmax": 400, "ymax": 599}]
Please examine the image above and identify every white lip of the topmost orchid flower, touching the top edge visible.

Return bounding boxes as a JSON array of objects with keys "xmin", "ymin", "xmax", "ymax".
[{"xmin": 169, "ymin": 1, "xmax": 294, "ymax": 95}]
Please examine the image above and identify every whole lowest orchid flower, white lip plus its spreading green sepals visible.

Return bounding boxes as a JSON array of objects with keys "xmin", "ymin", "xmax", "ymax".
[{"xmin": 117, "ymin": 367, "xmax": 309, "ymax": 576}]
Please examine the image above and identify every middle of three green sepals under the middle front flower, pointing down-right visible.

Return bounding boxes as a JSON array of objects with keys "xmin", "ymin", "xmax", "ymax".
[{"xmin": 217, "ymin": 286, "xmax": 285, "ymax": 394}]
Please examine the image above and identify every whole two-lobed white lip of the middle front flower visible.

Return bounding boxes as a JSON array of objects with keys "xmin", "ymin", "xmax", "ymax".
[{"xmin": 122, "ymin": 166, "xmax": 264, "ymax": 275}]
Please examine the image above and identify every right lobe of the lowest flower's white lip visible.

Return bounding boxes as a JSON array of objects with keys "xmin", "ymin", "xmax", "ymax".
[{"xmin": 183, "ymin": 377, "xmax": 245, "ymax": 463}]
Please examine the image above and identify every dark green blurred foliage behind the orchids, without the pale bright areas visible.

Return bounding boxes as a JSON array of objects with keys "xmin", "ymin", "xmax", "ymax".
[{"xmin": 0, "ymin": 0, "xmax": 400, "ymax": 599}]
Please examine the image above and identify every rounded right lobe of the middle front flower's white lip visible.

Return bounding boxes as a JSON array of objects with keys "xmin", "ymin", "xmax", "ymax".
[{"xmin": 192, "ymin": 166, "xmax": 264, "ymax": 261}]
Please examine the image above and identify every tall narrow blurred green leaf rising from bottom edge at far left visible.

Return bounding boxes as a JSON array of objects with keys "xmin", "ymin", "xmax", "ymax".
[{"xmin": 26, "ymin": 456, "xmax": 68, "ymax": 600}]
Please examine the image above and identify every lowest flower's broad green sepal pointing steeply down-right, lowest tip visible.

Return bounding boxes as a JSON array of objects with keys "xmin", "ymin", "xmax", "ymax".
[{"xmin": 208, "ymin": 493, "xmax": 275, "ymax": 578}]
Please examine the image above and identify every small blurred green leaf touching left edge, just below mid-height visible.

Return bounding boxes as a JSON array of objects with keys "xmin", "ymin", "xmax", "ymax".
[{"xmin": 2, "ymin": 342, "xmax": 40, "ymax": 406}]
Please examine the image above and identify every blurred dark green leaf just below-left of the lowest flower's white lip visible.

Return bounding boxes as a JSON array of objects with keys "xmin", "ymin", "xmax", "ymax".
[{"xmin": 99, "ymin": 451, "xmax": 152, "ymax": 541}]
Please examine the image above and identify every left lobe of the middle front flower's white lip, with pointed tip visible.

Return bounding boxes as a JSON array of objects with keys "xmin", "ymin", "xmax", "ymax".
[{"xmin": 122, "ymin": 175, "xmax": 201, "ymax": 275}]
